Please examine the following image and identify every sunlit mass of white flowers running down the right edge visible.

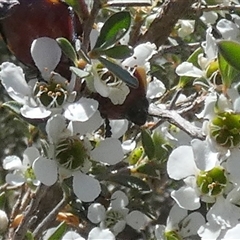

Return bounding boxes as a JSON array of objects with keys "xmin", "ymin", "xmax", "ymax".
[{"xmin": 164, "ymin": 12, "xmax": 240, "ymax": 240}]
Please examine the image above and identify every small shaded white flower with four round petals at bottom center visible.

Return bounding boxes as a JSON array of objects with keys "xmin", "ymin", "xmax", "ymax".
[{"xmin": 88, "ymin": 191, "xmax": 146, "ymax": 235}]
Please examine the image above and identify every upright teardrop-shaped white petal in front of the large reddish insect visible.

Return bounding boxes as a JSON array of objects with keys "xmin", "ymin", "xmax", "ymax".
[{"xmin": 31, "ymin": 37, "xmax": 62, "ymax": 81}]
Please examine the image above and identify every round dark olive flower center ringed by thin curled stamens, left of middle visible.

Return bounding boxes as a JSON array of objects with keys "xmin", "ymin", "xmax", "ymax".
[{"xmin": 56, "ymin": 137, "xmax": 88, "ymax": 170}]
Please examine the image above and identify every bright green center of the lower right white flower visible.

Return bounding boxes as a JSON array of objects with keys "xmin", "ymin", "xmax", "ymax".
[{"xmin": 197, "ymin": 167, "xmax": 227, "ymax": 196}]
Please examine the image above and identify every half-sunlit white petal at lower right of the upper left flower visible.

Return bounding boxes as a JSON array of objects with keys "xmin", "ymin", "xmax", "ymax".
[{"xmin": 64, "ymin": 98, "xmax": 98, "ymax": 122}]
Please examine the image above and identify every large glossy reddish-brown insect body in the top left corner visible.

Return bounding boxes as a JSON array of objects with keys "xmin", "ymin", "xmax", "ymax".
[{"xmin": 0, "ymin": 0, "xmax": 82, "ymax": 78}]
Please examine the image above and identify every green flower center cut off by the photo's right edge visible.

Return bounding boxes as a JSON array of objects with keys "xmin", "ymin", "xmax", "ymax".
[{"xmin": 210, "ymin": 112, "xmax": 240, "ymax": 148}]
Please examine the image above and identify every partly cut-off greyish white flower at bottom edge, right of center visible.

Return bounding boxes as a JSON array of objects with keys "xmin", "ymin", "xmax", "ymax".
[{"xmin": 155, "ymin": 204, "xmax": 205, "ymax": 240}]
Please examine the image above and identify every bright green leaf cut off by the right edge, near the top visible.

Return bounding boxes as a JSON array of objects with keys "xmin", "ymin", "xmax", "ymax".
[{"xmin": 218, "ymin": 40, "xmax": 240, "ymax": 71}]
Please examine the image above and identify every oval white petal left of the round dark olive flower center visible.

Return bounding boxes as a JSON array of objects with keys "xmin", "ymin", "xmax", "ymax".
[{"xmin": 33, "ymin": 157, "xmax": 58, "ymax": 186}]
